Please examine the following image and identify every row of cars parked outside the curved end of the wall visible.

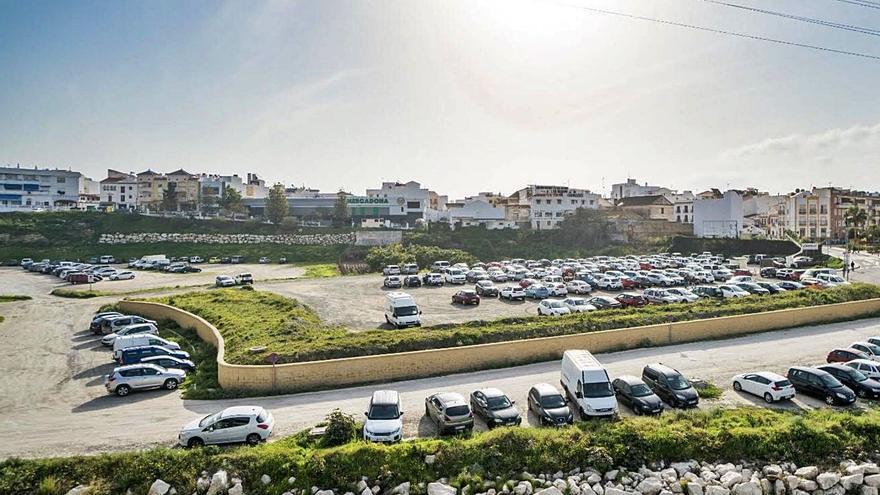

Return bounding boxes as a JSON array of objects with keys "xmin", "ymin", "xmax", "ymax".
[{"xmin": 89, "ymin": 311, "xmax": 196, "ymax": 397}]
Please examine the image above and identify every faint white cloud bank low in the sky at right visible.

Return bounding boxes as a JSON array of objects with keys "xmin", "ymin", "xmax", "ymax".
[{"xmin": 721, "ymin": 123, "xmax": 880, "ymax": 159}]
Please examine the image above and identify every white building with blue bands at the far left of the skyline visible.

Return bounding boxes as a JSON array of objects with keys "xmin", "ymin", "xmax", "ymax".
[{"xmin": 0, "ymin": 166, "xmax": 83, "ymax": 211}]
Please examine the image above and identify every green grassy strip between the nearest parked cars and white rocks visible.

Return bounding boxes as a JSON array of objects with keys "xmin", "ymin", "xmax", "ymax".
[{"xmin": 0, "ymin": 407, "xmax": 880, "ymax": 495}]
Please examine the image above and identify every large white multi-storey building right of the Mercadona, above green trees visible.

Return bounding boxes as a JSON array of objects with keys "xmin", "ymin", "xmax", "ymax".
[{"xmin": 526, "ymin": 185, "xmax": 603, "ymax": 230}]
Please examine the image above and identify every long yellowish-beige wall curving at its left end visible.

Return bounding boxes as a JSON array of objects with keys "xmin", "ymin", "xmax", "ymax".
[{"xmin": 119, "ymin": 299, "xmax": 880, "ymax": 391}]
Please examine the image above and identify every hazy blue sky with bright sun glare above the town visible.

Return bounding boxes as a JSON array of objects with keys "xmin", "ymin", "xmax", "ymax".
[{"xmin": 0, "ymin": 0, "xmax": 880, "ymax": 199}]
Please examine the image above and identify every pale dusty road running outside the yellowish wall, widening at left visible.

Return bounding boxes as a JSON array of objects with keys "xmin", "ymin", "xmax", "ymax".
[{"xmin": 0, "ymin": 269, "xmax": 880, "ymax": 458}]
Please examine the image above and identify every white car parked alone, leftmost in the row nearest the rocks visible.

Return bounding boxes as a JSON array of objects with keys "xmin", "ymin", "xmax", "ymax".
[{"xmin": 177, "ymin": 406, "xmax": 275, "ymax": 447}]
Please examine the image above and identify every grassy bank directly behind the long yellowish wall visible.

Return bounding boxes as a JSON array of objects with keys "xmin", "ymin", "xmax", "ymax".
[{"xmin": 153, "ymin": 284, "xmax": 880, "ymax": 364}]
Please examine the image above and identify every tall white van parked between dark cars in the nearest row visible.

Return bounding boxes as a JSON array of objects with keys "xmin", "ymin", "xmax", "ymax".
[{"xmin": 561, "ymin": 350, "xmax": 617, "ymax": 418}]
